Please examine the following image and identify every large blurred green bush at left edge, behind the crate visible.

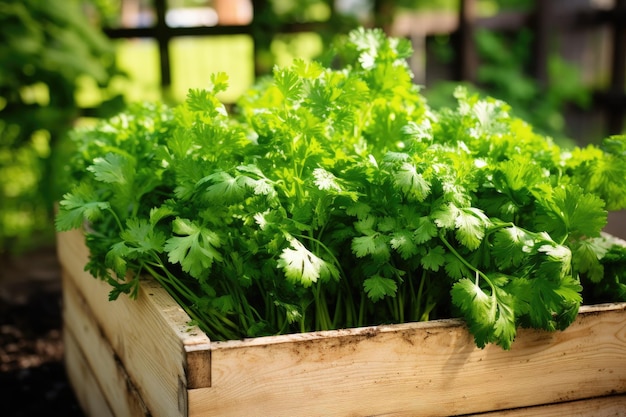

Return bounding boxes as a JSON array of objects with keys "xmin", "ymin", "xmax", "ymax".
[{"xmin": 0, "ymin": 0, "xmax": 121, "ymax": 253}]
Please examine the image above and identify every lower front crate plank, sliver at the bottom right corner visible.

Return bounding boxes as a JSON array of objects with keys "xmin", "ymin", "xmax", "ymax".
[{"xmin": 467, "ymin": 395, "xmax": 626, "ymax": 417}]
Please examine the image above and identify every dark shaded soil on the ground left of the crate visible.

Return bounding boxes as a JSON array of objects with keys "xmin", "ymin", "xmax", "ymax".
[{"xmin": 0, "ymin": 248, "xmax": 84, "ymax": 417}]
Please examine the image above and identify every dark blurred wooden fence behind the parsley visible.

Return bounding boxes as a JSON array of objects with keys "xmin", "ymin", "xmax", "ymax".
[{"xmin": 100, "ymin": 0, "xmax": 626, "ymax": 140}]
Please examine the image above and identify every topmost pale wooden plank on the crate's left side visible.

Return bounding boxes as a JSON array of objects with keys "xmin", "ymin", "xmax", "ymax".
[{"xmin": 57, "ymin": 230, "xmax": 210, "ymax": 417}]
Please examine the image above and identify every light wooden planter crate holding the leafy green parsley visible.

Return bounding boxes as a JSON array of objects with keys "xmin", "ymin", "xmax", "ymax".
[{"xmin": 58, "ymin": 231, "xmax": 626, "ymax": 417}]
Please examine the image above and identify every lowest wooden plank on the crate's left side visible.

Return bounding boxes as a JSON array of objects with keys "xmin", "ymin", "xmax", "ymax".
[{"xmin": 63, "ymin": 328, "xmax": 115, "ymax": 417}]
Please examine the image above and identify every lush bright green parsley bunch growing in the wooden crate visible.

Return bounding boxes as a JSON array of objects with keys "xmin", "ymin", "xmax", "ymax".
[{"xmin": 56, "ymin": 29, "xmax": 626, "ymax": 348}]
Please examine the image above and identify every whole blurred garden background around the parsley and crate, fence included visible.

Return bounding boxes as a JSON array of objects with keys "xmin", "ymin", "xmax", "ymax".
[{"xmin": 0, "ymin": 0, "xmax": 626, "ymax": 415}]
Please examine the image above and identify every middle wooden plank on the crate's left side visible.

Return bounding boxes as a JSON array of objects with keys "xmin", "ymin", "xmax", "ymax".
[{"xmin": 63, "ymin": 273, "xmax": 149, "ymax": 417}]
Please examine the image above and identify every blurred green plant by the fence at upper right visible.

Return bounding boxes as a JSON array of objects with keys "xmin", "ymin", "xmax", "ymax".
[{"xmin": 425, "ymin": 0, "xmax": 591, "ymax": 144}]
